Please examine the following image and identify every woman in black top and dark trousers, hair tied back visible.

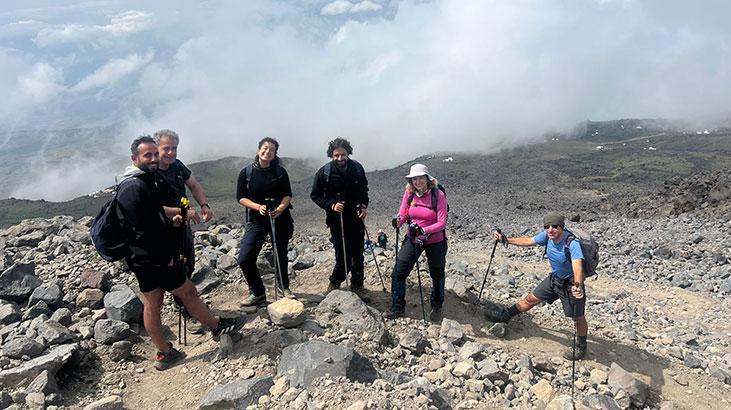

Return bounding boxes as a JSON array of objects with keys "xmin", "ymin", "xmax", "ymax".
[{"xmin": 236, "ymin": 137, "xmax": 295, "ymax": 306}]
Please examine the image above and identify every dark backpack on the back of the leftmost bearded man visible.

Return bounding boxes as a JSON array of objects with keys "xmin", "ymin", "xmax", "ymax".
[{"xmin": 90, "ymin": 180, "xmax": 130, "ymax": 262}]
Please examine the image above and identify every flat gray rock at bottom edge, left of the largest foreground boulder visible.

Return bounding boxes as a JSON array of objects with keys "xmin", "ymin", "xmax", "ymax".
[{"xmin": 198, "ymin": 376, "xmax": 274, "ymax": 410}]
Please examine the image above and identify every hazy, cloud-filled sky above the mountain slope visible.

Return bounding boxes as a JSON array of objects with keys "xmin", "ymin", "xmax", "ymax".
[{"xmin": 0, "ymin": 0, "xmax": 731, "ymax": 199}]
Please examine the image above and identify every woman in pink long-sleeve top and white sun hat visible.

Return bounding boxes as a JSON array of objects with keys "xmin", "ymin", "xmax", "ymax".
[{"xmin": 384, "ymin": 164, "xmax": 447, "ymax": 321}]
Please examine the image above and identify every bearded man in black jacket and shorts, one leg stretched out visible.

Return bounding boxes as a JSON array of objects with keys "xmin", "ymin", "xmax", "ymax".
[{"xmin": 117, "ymin": 135, "xmax": 245, "ymax": 370}]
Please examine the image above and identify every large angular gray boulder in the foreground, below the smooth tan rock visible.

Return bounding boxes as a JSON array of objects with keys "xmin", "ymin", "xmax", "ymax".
[{"xmin": 277, "ymin": 340, "xmax": 378, "ymax": 387}]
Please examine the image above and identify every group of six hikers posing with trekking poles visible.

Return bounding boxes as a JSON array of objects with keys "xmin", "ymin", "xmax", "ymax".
[{"xmin": 92, "ymin": 130, "xmax": 596, "ymax": 370}]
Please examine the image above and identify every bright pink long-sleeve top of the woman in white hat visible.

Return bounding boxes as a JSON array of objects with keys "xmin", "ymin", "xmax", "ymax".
[{"xmin": 398, "ymin": 187, "xmax": 447, "ymax": 245}]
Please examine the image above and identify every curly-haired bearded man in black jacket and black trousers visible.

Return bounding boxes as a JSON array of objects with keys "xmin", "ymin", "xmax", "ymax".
[{"xmin": 310, "ymin": 138, "xmax": 368, "ymax": 292}]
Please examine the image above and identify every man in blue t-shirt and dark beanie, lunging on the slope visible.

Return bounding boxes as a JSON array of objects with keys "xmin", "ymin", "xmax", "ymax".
[{"xmin": 486, "ymin": 212, "xmax": 589, "ymax": 360}]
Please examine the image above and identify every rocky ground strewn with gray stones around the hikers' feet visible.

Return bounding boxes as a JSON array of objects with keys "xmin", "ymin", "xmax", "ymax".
[{"xmin": 0, "ymin": 158, "xmax": 731, "ymax": 409}]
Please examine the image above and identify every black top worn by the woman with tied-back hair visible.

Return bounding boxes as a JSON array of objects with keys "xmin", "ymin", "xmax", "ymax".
[{"xmin": 236, "ymin": 164, "xmax": 292, "ymax": 221}]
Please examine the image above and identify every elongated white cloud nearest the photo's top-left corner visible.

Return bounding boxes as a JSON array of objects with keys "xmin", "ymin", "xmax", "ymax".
[{"xmin": 34, "ymin": 10, "xmax": 152, "ymax": 47}]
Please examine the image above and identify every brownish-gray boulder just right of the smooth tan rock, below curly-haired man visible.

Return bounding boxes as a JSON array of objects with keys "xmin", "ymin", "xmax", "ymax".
[{"xmin": 315, "ymin": 290, "xmax": 390, "ymax": 344}]
